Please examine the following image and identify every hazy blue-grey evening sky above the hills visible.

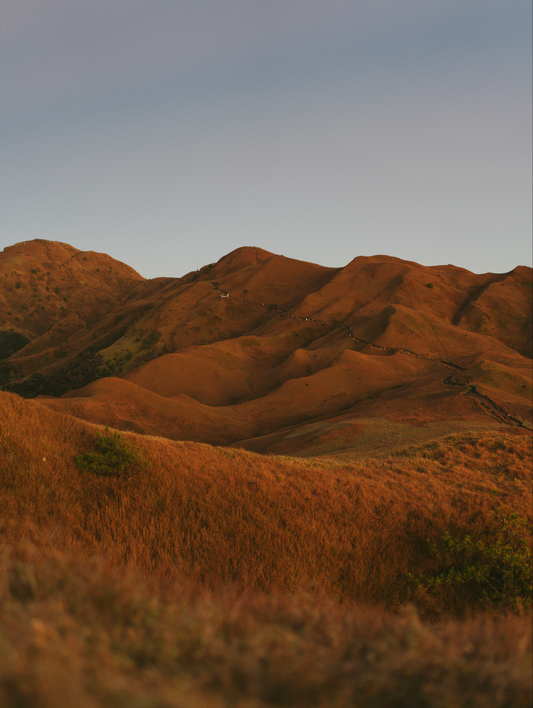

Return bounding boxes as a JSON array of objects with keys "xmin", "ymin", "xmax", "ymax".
[{"xmin": 0, "ymin": 0, "xmax": 532, "ymax": 278}]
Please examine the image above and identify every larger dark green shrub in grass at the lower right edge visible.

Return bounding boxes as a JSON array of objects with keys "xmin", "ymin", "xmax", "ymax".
[{"xmin": 408, "ymin": 509, "xmax": 533, "ymax": 610}]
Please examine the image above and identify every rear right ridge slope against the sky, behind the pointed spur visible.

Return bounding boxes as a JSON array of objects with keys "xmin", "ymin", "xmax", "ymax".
[{"xmin": 290, "ymin": 256, "xmax": 532, "ymax": 357}]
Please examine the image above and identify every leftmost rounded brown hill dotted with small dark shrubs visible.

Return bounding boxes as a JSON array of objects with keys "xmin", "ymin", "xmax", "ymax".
[{"xmin": 0, "ymin": 239, "xmax": 145, "ymax": 378}]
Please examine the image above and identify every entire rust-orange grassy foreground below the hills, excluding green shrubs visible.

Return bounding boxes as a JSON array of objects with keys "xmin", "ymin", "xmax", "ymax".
[{"xmin": 0, "ymin": 393, "xmax": 532, "ymax": 708}]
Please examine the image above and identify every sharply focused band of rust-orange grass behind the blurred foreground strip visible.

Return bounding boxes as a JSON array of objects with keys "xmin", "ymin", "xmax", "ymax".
[{"xmin": 0, "ymin": 394, "xmax": 531, "ymax": 614}]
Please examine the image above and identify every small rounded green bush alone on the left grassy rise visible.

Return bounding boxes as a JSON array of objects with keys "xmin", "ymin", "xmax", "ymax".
[{"xmin": 74, "ymin": 427, "xmax": 147, "ymax": 477}]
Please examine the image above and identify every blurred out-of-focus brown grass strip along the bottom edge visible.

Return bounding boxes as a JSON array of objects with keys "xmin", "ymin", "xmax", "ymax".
[{"xmin": 0, "ymin": 545, "xmax": 532, "ymax": 708}]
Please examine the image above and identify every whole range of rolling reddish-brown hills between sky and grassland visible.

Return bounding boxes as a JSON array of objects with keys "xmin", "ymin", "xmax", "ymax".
[{"xmin": 0, "ymin": 241, "xmax": 532, "ymax": 455}]
